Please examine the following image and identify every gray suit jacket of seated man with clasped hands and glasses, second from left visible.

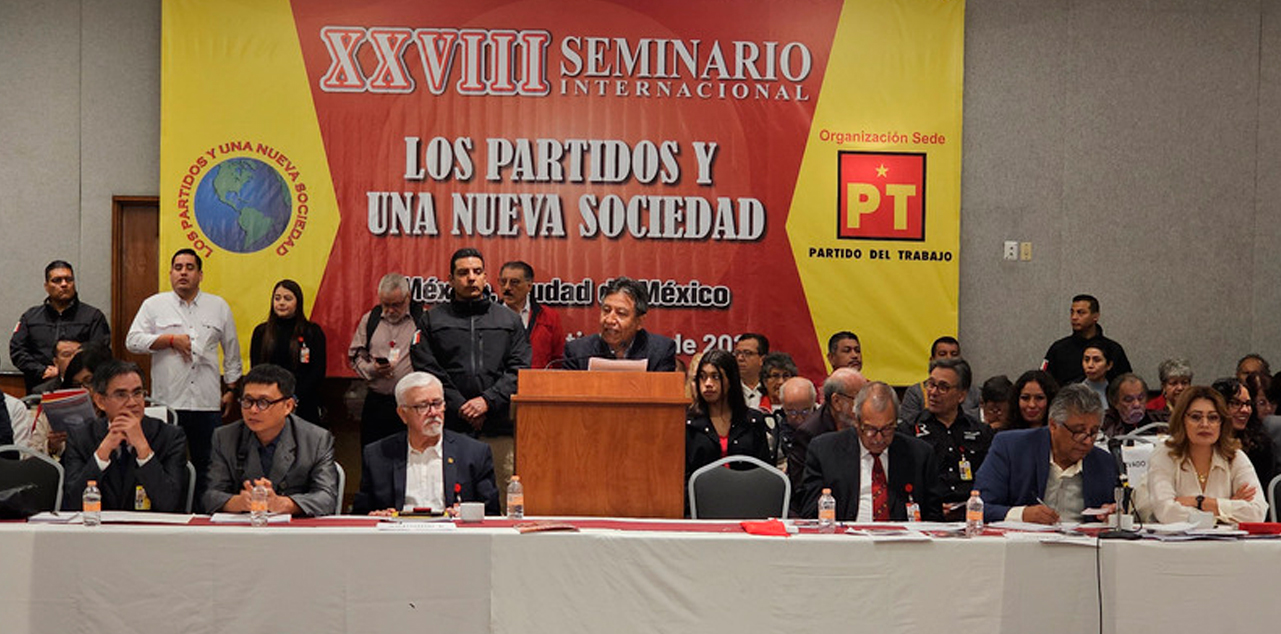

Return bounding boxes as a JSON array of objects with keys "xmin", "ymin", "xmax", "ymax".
[{"xmin": 204, "ymin": 414, "xmax": 338, "ymax": 516}]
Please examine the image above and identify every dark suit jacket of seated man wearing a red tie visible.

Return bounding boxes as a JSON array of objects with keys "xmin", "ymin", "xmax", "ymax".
[{"xmin": 793, "ymin": 429, "xmax": 943, "ymax": 521}]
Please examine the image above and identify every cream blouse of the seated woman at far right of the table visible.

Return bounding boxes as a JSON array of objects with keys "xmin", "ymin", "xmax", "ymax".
[{"xmin": 1135, "ymin": 446, "xmax": 1268, "ymax": 524}]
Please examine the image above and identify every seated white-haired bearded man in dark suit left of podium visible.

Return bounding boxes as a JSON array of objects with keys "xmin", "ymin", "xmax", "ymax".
[{"xmin": 351, "ymin": 371, "xmax": 498, "ymax": 515}]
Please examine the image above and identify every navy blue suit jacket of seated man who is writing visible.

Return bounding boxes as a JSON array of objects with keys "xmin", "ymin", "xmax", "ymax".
[{"xmin": 975, "ymin": 427, "xmax": 1117, "ymax": 521}]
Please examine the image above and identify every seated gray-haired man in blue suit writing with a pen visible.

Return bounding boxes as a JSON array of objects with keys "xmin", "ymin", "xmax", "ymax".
[{"xmin": 975, "ymin": 383, "xmax": 1117, "ymax": 524}]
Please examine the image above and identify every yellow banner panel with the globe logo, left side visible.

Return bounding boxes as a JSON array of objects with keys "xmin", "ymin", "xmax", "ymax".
[{"xmin": 160, "ymin": 0, "xmax": 338, "ymax": 359}]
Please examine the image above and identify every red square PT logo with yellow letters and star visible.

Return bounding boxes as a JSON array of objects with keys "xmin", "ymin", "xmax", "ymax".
[{"xmin": 836, "ymin": 152, "xmax": 925, "ymax": 242}]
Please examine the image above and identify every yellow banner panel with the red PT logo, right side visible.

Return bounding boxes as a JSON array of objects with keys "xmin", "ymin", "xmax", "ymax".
[{"xmin": 787, "ymin": 0, "xmax": 965, "ymax": 384}]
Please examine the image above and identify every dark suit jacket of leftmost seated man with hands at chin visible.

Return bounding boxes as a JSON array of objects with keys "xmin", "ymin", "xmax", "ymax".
[{"xmin": 63, "ymin": 416, "xmax": 187, "ymax": 512}]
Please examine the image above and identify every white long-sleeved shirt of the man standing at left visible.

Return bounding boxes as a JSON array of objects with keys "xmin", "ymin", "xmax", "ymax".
[{"xmin": 124, "ymin": 291, "xmax": 241, "ymax": 411}]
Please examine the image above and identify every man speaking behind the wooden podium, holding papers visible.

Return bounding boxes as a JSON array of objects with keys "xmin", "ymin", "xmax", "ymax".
[{"xmin": 565, "ymin": 277, "xmax": 676, "ymax": 371}]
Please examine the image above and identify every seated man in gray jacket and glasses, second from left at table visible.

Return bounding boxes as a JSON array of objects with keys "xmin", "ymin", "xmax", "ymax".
[{"xmin": 204, "ymin": 364, "xmax": 338, "ymax": 516}]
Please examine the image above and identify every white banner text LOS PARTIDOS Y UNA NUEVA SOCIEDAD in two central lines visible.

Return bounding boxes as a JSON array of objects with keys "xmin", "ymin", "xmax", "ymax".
[{"xmin": 366, "ymin": 137, "xmax": 766, "ymax": 241}]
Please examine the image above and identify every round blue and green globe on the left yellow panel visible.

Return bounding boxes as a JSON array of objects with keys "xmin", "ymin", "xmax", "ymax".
[{"xmin": 195, "ymin": 158, "xmax": 293, "ymax": 254}]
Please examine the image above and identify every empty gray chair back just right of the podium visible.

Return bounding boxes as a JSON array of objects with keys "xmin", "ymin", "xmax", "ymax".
[{"xmin": 689, "ymin": 456, "xmax": 792, "ymax": 520}]
